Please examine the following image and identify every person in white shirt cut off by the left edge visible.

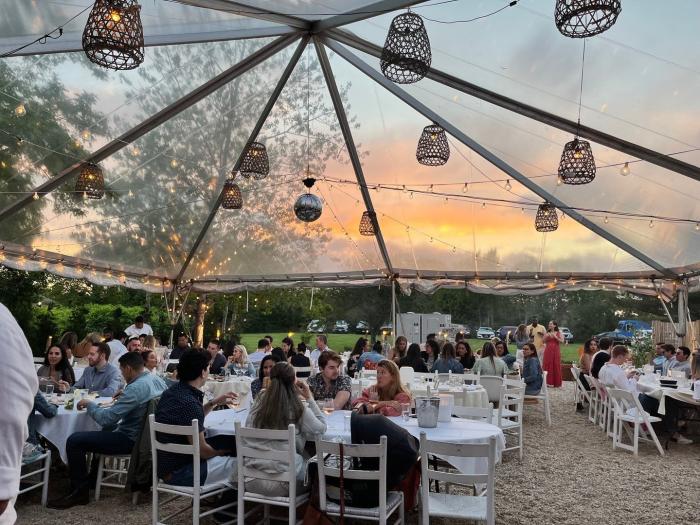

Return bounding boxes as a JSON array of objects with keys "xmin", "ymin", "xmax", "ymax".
[{"xmin": 0, "ymin": 303, "xmax": 39, "ymax": 525}]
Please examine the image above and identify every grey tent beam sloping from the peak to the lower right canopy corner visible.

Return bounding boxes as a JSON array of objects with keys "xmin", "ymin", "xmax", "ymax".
[{"xmin": 324, "ymin": 39, "xmax": 677, "ymax": 278}]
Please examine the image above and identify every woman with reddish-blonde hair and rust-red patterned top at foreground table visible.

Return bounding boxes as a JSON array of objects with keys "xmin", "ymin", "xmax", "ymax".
[{"xmin": 352, "ymin": 359, "xmax": 411, "ymax": 416}]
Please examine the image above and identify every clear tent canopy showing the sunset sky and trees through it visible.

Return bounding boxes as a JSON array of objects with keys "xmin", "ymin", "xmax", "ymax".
[{"xmin": 0, "ymin": 0, "xmax": 700, "ymax": 298}]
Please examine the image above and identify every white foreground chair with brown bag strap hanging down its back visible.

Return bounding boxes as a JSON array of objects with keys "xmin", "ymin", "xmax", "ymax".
[{"xmin": 316, "ymin": 436, "xmax": 404, "ymax": 525}]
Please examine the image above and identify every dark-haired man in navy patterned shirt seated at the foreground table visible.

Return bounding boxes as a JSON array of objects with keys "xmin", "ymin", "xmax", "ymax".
[{"xmin": 155, "ymin": 350, "xmax": 237, "ymax": 487}]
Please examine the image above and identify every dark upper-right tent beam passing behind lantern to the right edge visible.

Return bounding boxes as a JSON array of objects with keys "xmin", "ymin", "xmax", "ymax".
[{"xmin": 327, "ymin": 29, "xmax": 700, "ymax": 181}]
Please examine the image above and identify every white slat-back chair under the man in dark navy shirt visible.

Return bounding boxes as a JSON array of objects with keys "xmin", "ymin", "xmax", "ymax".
[{"xmin": 148, "ymin": 414, "xmax": 237, "ymax": 525}]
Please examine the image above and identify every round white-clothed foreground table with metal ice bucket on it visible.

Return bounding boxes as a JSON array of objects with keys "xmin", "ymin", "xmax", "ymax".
[{"xmin": 204, "ymin": 409, "xmax": 506, "ymax": 473}]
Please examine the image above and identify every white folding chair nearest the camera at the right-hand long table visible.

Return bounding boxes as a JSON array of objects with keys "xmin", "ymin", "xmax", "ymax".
[{"xmin": 608, "ymin": 388, "xmax": 665, "ymax": 456}]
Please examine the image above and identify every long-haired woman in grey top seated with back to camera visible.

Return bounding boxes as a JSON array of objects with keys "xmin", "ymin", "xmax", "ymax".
[{"xmin": 238, "ymin": 362, "xmax": 326, "ymax": 496}]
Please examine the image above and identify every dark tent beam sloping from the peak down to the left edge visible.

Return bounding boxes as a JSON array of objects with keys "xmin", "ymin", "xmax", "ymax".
[{"xmin": 0, "ymin": 34, "xmax": 299, "ymax": 222}]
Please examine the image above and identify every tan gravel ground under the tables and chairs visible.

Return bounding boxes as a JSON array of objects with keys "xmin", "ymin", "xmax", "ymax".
[{"xmin": 17, "ymin": 383, "xmax": 700, "ymax": 525}]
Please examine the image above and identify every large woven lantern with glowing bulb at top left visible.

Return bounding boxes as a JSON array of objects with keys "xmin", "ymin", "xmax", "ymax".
[{"xmin": 83, "ymin": 0, "xmax": 144, "ymax": 71}]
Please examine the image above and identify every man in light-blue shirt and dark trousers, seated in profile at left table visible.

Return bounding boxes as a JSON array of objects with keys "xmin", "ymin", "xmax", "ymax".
[{"xmin": 48, "ymin": 352, "xmax": 166, "ymax": 509}]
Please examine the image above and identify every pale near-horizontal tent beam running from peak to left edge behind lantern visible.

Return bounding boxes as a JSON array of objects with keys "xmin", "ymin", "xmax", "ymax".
[{"xmin": 0, "ymin": 26, "xmax": 295, "ymax": 57}]
